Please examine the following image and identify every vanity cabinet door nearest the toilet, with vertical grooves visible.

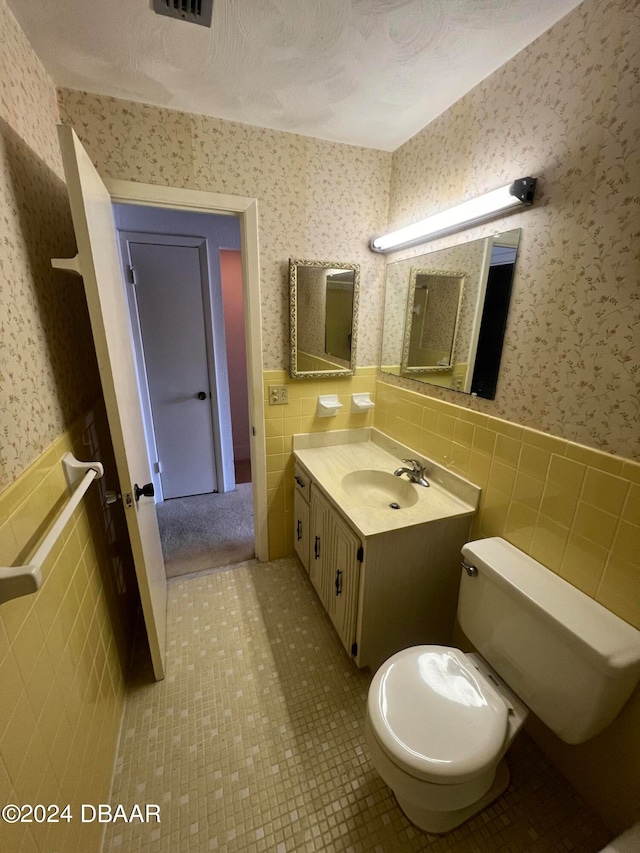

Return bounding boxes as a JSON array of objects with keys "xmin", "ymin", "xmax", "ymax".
[{"xmin": 327, "ymin": 512, "xmax": 360, "ymax": 654}]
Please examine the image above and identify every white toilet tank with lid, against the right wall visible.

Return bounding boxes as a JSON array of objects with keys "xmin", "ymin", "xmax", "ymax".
[{"xmin": 458, "ymin": 537, "xmax": 640, "ymax": 743}]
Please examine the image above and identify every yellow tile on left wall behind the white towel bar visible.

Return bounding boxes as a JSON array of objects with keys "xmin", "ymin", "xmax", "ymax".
[{"xmin": 0, "ymin": 410, "xmax": 135, "ymax": 853}]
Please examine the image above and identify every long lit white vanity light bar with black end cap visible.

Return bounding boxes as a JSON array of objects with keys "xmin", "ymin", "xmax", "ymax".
[{"xmin": 370, "ymin": 178, "xmax": 536, "ymax": 253}]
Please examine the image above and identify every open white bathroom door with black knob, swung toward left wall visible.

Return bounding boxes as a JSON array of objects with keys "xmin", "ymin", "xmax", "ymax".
[{"xmin": 58, "ymin": 126, "xmax": 167, "ymax": 681}]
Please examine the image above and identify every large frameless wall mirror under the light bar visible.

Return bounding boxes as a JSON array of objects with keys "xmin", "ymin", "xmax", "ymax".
[{"xmin": 381, "ymin": 228, "xmax": 520, "ymax": 400}]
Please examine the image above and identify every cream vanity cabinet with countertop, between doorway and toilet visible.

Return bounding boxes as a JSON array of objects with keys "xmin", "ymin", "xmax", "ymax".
[{"xmin": 294, "ymin": 445, "xmax": 479, "ymax": 671}]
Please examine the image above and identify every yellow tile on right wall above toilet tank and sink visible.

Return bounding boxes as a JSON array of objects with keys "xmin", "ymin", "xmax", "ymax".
[{"xmin": 373, "ymin": 381, "xmax": 640, "ymax": 628}]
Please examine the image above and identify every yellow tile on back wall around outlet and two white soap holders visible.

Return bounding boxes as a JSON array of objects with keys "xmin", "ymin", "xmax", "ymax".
[{"xmin": 263, "ymin": 367, "xmax": 377, "ymax": 560}]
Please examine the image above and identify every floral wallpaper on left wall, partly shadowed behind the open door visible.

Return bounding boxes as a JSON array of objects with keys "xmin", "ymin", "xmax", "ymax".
[{"xmin": 0, "ymin": 0, "xmax": 99, "ymax": 490}]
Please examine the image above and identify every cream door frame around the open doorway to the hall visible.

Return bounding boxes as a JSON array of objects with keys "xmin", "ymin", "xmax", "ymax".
[{"xmin": 104, "ymin": 178, "xmax": 269, "ymax": 561}]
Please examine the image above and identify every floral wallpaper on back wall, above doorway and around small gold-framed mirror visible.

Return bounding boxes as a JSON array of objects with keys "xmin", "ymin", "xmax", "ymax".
[{"xmin": 59, "ymin": 89, "xmax": 391, "ymax": 369}]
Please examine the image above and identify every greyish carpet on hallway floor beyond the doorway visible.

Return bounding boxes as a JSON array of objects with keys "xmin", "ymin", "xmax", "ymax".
[{"xmin": 157, "ymin": 483, "xmax": 255, "ymax": 578}]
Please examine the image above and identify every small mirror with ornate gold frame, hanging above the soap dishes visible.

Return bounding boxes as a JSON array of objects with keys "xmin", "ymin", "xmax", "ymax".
[{"xmin": 289, "ymin": 258, "xmax": 360, "ymax": 379}]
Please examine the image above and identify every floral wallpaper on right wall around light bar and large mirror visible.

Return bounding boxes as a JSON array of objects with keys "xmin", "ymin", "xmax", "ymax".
[{"xmin": 387, "ymin": 0, "xmax": 640, "ymax": 459}]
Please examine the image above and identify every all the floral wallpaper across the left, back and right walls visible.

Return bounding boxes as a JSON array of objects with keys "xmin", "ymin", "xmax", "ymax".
[{"xmin": 0, "ymin": 0, "xmax": 640, "ymax": 487}]
